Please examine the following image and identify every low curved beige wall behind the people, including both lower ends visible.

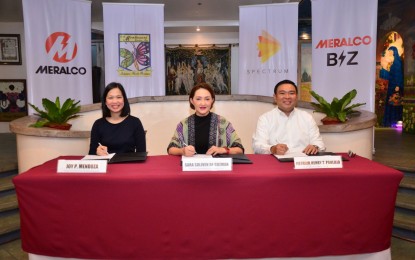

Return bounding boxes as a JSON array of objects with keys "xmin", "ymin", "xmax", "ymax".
[{"xmin": 17, "ymin": 100, "xmax": 373, "ymax": 172}]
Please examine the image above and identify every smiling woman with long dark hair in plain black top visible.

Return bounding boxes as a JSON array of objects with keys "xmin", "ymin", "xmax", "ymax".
[{"xmin": 89, "ymin": 82, "xmax": 146, "ymax": 155}]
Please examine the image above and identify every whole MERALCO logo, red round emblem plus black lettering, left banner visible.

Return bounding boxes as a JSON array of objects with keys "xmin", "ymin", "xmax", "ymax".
[{"xmin": 36, "ymin": 32, "xmax": 86, "ymax": 75}]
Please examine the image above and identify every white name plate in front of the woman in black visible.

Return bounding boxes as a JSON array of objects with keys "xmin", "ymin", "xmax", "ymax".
[{"xmin": 57, "ymin": 160, "xmax": 108, "ymax": 173}]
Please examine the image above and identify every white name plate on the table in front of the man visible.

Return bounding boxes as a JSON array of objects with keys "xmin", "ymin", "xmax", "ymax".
[{"xmin": 294, "ymin": 155, "xmax": 343, "ymax": 169}]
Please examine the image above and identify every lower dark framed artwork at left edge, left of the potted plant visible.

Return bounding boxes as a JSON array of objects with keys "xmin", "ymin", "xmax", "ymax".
[{"xmin": 0, "ymin": 79, "xmax": 28, "ymax": 122}]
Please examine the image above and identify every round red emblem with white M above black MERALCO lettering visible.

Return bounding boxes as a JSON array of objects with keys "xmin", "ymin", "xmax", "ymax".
[{"xmin": 45, "ymin": 32, "xmax": 78, "ymax": 63}]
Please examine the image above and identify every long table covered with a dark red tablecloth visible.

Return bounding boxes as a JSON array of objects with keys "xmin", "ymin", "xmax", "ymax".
[{"xmin": 13, "ymin": 155, "xmax": 403, "ymax": 259}]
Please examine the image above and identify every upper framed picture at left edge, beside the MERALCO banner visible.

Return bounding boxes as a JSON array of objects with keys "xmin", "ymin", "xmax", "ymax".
[{"xmin": 0, "ymin": 34, "xmax": 22, "ymax": 65}]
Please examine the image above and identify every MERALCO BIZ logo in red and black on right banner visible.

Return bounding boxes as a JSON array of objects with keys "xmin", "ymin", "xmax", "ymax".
[{"xmin": 316, "ymin": 35, "xmax": 372, "ymax": 67}]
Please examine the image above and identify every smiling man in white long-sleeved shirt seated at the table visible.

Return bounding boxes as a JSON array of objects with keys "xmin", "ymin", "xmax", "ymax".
[{"xmin": 252, "ymin": 80, "xmax": 325, "ymax": 155}]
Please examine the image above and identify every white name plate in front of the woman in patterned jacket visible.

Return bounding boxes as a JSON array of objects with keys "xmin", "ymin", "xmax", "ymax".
[{"xmin": 182, "ymin": 156, "xmax": 232, "ymax": 171}]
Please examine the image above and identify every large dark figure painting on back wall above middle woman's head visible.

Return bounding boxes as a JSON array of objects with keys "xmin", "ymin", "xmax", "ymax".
[{"xmin": 165, "ymin": 46, "xmax": 231, "ymax": 95}]
